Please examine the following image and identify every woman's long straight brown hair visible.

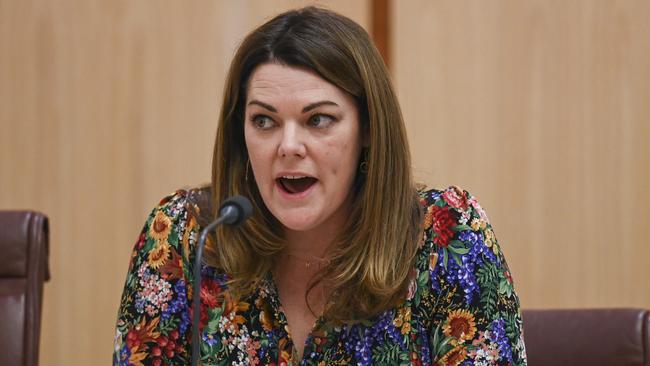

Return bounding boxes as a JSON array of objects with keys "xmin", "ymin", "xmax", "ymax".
[{"xmin": 206, "ymin": 7, "xmax": 422, "ymax": 322}]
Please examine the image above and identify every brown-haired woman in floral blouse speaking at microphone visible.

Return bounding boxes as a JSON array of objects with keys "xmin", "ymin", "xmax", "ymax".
[{"xmin": 114, "ymin": 7, "xmax": 526, "ymax": 365}]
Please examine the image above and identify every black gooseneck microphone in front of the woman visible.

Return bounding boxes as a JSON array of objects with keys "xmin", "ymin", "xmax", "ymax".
[{"xmin": 192, "ymin": 196, "xmax": 253, "ymax": 366}]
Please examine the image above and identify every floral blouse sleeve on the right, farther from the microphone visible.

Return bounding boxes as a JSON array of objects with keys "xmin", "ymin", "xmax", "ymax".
[{"xmin": 425, "ymin": 187, "xmax": 527, "ymax": 365}]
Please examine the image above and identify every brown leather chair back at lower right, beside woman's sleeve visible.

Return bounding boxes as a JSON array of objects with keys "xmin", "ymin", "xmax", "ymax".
[{"xmin": 523, "ymin": 309, "xmax": 650, "ymax": 366}]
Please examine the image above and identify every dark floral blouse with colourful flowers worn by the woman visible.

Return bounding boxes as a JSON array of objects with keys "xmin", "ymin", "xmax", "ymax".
[{"xmin": 113, "ymin": 187, "xmax": 526, "ymax": 366}]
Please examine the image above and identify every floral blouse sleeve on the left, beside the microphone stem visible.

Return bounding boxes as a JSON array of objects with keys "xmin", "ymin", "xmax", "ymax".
[{"xmin": 113, "ymin": 191, "xmax": 196, "ymax": 365}]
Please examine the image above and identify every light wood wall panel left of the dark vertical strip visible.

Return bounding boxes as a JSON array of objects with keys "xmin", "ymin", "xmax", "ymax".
[{"xmin": 0, "ymin": 0, "xmax": 369, "ymax": 366}]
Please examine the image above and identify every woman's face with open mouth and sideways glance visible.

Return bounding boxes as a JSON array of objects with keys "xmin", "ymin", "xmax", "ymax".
[{"xmin": 244, "ymin": 63, "xmax": 362, "ymax": 231}]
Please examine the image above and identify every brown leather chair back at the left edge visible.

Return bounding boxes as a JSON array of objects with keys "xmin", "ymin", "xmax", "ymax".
[{"xmin": 0, "ymin": 211, "xmax": 49, "ymax": 366}]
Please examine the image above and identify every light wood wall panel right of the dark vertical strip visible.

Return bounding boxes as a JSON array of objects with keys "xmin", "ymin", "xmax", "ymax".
[{"xmin": 392, "ymin": 0, "xmax": 650, "ymax": 308}]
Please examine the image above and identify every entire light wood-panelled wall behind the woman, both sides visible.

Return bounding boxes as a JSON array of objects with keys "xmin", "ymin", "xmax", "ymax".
[{"xmin": 0, "ymin": 0, "xmax": 650, "ymax": 365}]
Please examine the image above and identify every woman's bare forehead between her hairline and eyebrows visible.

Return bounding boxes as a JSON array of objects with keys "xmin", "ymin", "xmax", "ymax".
[{"xmin": 246, "ymin": 63, "xmax": 347, "ymax": 100}]
